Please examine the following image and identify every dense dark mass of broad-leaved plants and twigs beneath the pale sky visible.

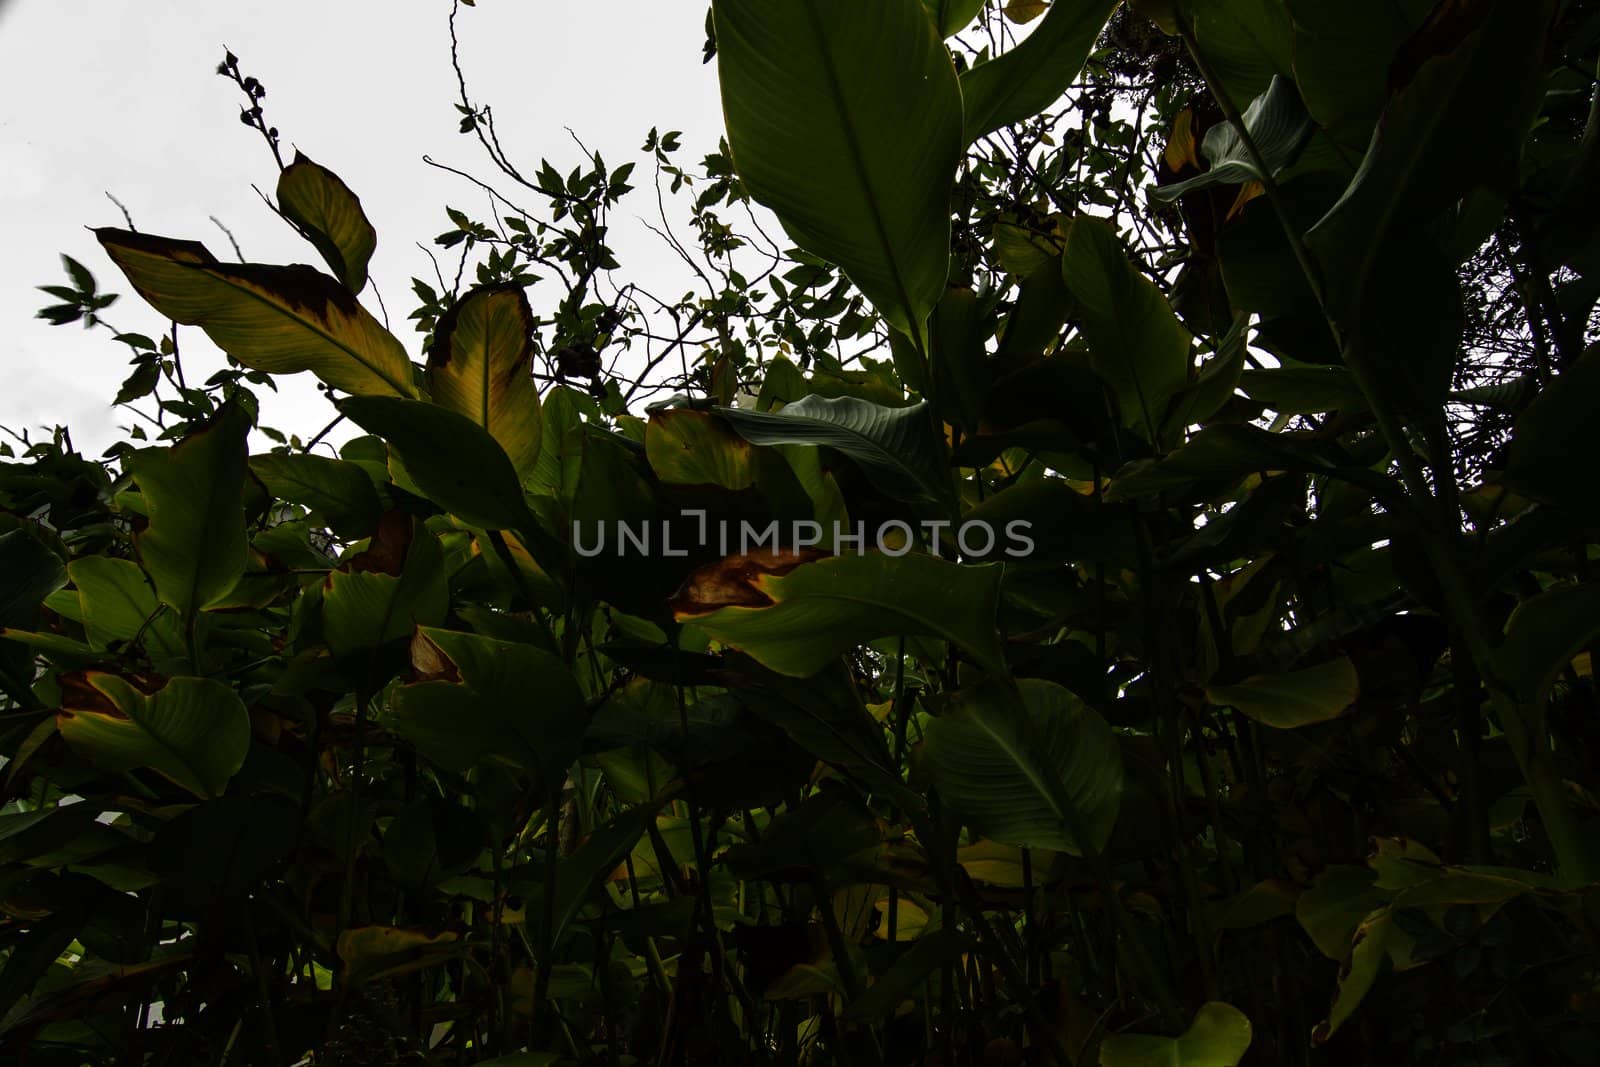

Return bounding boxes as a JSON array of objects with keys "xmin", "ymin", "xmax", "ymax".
[{"xmin": 0, "ymin": 0, "xmax": 1600, "ymax": 1067}]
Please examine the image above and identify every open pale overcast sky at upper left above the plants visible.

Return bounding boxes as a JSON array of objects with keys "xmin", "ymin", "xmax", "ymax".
[{"xmin": 0, "ymin": 0, "xmax": 722, "ymax": 454}]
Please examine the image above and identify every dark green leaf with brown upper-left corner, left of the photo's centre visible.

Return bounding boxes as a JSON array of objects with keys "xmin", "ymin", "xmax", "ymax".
[{"xmin": 392, "ymin": 627, "xmax": 587, "ymax": 781}]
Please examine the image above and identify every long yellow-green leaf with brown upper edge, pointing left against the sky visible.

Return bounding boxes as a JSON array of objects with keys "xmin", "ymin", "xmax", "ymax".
[{"xmin": 94, "ymin": 229, "xmax": 416, "ymax": 397}]
